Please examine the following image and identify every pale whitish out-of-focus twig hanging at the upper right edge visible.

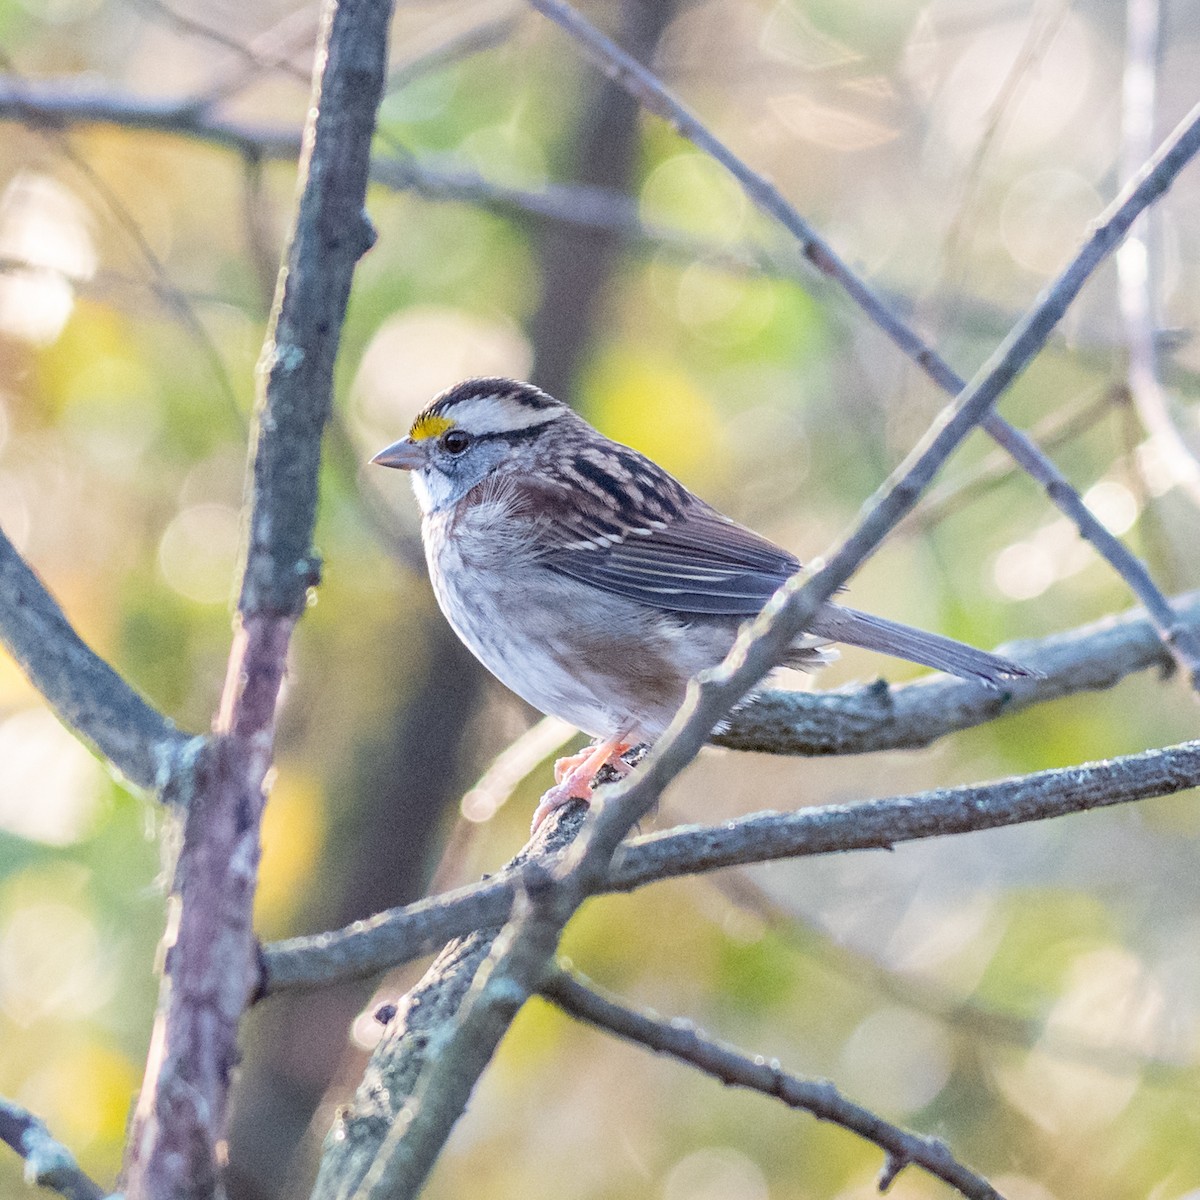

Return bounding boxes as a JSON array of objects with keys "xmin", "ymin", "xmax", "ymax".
[{"xmin": 1117, "ymin": 0, "xmax": 1200, "ymax": 506}]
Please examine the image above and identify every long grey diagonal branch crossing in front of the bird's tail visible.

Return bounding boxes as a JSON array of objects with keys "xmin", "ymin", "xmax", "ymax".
[{"xmin": 323, "ymin": 23, "xmax": 1200, "ymax": 1200}]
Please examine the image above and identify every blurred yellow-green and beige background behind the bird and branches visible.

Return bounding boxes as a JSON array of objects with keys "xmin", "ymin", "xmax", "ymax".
[{"xmin": 0, "ymin": 0, "xmax": 1200, "ymax": 1200}]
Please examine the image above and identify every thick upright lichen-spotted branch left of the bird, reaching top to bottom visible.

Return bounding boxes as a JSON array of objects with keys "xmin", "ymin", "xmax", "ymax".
[{"xmin": 126, "ymin": 0, "xmax": 391, "ymax": 1200}]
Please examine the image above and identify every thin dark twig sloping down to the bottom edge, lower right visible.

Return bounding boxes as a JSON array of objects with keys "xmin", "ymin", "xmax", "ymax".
[{"xmin": 541, "ymin": 965, "xmax": 1002, "ymax": 1200}]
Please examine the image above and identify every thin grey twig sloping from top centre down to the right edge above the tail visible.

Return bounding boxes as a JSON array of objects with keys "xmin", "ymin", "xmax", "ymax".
[{"xmin": 529, "ymin": 0, "xmax": 1200, "ymax": 691}]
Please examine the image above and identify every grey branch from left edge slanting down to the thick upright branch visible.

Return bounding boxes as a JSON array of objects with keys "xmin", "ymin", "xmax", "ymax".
[{"xmin": 0, "ymin": 532, "xmax": 188, "ymax": 788}]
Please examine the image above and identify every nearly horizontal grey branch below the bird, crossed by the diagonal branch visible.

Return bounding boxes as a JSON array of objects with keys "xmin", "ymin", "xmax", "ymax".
[{"xmin": 263, "ymin": 742, "xmax": 1200, "ymax": 995}]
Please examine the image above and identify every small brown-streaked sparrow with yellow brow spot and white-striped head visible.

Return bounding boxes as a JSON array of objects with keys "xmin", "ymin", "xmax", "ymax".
[{"xmin": 371, "ymin": 378, "xmax": 1037, "ymax": 829}]
